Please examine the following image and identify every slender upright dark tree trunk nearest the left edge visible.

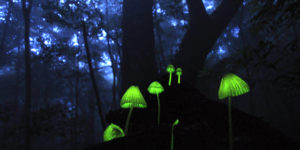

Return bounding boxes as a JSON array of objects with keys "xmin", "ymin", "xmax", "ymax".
[{"xmin": 22, "ymin": 0, "xmax": 32, "ymax": 150}]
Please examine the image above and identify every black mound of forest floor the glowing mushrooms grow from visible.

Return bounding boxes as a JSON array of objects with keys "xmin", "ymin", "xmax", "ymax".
[{"xmin": 86, "ymin": 77, "xmax": 300, "ymax": 150}]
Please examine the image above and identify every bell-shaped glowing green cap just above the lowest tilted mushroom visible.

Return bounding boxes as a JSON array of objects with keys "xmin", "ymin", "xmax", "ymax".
[{"xmin": 120, "ymin": 86, "xmax": 147, "ymax": 108}]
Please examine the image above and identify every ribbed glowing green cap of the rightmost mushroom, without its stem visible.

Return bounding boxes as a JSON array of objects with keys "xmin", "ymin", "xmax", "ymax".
[{"xmin": 218, "ymin": 73, "xmax": 250, "ymax": 99}]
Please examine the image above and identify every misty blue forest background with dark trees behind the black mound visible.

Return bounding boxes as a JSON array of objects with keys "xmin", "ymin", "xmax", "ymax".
[{"xmin": 0, "ymin": 0, "xmax": 300, "ymax": 150}]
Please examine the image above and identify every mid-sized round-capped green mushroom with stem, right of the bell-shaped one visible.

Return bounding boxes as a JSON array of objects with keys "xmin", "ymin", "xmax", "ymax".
[{"xmin": 148, "ymin": 81, "xmax": 164, "ymax": 125}]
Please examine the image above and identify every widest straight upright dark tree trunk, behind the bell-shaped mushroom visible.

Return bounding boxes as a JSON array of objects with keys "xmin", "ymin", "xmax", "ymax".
[{"xmin": 121, "ymin": 0, "xmax": 157, "ymax": 94}]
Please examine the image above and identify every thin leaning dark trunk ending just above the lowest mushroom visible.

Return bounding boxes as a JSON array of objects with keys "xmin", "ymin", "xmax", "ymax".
[{"xmin": 82, "ymin": 21, "xmax": 106, "ymax": 129}]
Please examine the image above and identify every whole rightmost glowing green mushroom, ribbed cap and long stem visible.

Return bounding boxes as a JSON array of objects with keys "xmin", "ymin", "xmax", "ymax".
[{"xmin": 218, "ymin": 73, "xmax": 250, "ymax": 150}]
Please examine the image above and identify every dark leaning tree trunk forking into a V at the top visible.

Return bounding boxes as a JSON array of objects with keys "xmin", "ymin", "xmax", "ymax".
[{"xmin": 174, "ymin": 0, "xmax": 242, "ymax": 85}]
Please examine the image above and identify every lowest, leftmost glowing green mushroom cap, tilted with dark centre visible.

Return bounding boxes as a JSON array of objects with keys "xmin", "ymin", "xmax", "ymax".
[{"xmin": 103, "ymin": 123, "xmax": 125, "ymax": 142}]
